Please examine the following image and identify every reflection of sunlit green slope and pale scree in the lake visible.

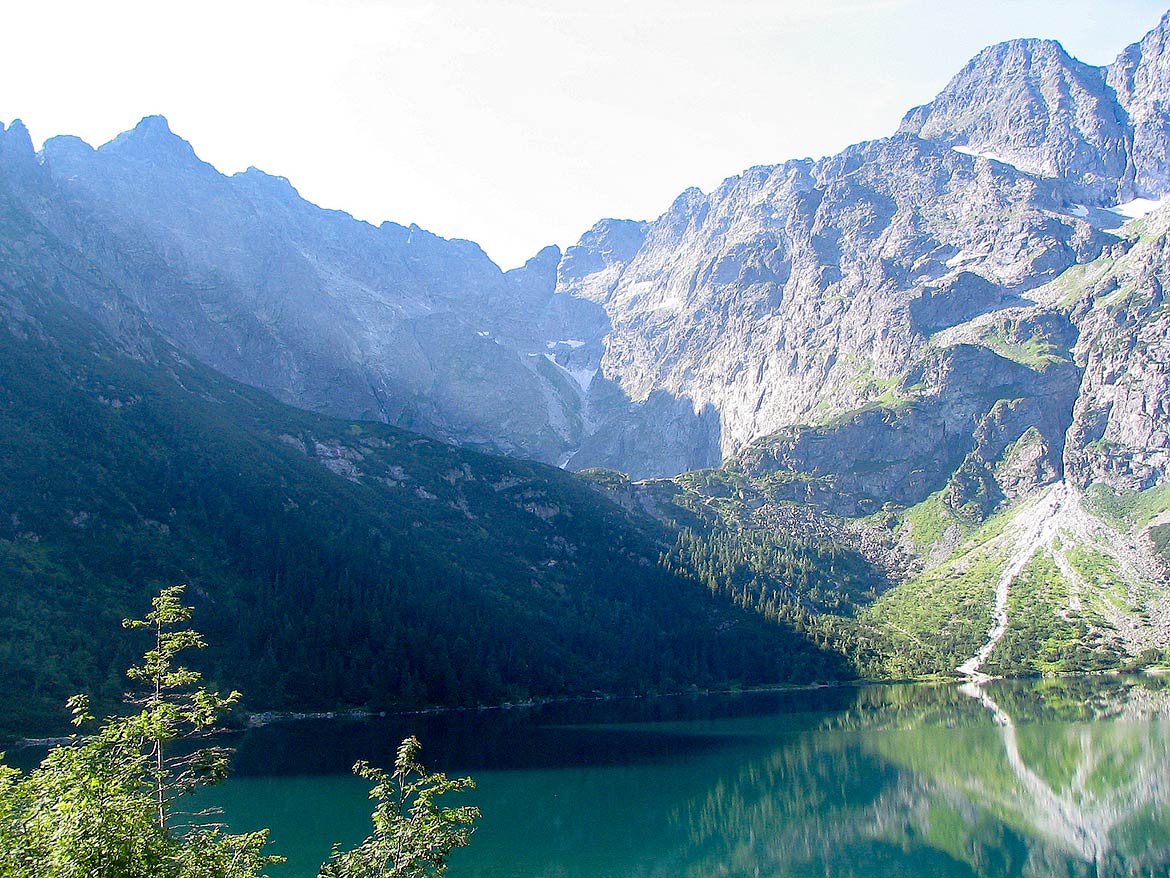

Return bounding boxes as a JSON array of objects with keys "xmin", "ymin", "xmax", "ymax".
[{"xmin": 676, "ymin": 680, "xmax": 1170, "ymax": 878}]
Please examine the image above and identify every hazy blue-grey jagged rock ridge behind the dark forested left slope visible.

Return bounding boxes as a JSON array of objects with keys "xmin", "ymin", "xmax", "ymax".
[{"xmin": 0, "ymin": 117, "xmax": 718, "ymax": 475}]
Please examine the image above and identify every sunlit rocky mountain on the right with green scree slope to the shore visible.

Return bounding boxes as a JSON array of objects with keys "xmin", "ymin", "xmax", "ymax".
[{"xmin": 558, "ymin": 16, "xmax": 1170, "ymax": 675}]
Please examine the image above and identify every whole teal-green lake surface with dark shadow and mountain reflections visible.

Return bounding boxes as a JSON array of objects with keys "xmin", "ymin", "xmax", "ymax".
[{"xmin": 187, "ymin": 677, "xmax": 1170, "ymax": 878}]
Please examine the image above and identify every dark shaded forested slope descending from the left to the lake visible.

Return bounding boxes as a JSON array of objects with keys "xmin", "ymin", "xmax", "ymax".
[{"xmin": 0, "ymin": 148, "xmax": 852, "ymax": 733}]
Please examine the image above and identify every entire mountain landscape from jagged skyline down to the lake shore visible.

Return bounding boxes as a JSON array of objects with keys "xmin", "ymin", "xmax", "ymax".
[{"xmin": 0, "ymin": 10, "xmax": 1170, "ymax": 734}]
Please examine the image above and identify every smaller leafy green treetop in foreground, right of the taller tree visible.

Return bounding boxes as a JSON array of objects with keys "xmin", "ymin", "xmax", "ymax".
[{"xmin": 318, "ymin": 738, "xmax": 480, "ymax": 878}]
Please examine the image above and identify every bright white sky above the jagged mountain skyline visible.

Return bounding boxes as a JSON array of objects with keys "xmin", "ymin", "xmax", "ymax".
[{"xmin": 0, "ymin": 0, "xmax": 1170, "ymax": 268}]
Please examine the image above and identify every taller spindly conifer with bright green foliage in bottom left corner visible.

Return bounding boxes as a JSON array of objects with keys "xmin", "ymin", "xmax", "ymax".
[{"xmin": 0, "ymin": 585, "xmax": 281, "ymax": 878}]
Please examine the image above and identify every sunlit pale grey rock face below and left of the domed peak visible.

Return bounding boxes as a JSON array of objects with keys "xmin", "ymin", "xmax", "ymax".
[{"xmin": 559, "ymin": 135, "xmax": 1114, "ymax": 482}]
